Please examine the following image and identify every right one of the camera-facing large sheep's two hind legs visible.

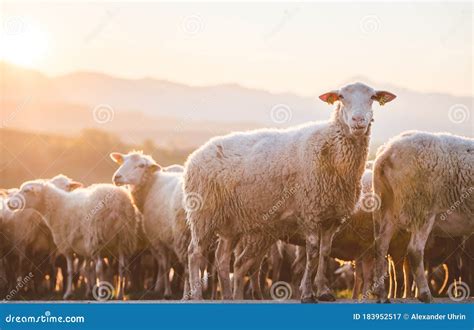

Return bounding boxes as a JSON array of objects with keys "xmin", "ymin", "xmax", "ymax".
[{"xmin": 216, "ymin": 237, "xmax": 238, "ymax": 300}]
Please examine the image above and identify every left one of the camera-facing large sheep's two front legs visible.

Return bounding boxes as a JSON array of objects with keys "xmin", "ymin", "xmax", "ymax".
[{"xmin": 300, "ymin": 234, "xmax": 319, "ymax": 303}]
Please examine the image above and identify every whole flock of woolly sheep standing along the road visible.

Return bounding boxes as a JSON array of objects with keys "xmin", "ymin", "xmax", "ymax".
[{"xmin": 0, "ymin": 83, "xmax": 474, "ymax": 303}]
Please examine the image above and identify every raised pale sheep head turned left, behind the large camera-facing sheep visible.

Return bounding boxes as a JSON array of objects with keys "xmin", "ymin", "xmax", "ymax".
[{"xmin": 110, "ymin": 152, "xmax": 161, "ymax": 186}]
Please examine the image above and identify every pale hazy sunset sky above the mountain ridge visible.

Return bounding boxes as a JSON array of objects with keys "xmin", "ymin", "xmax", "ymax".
[{"xmin": 0, "ymin": 1, "xmax": 474, "ymax": 96}]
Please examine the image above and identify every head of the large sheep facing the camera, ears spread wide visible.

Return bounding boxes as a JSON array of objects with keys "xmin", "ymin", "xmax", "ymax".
[{"xmin": 319, "ymin": 83, "xmax": 396, "ymax": 136}]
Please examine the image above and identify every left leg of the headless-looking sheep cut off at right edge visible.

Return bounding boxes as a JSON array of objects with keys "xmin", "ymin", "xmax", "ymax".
[{"xmin": 374, "ymin": 217, "xmax": 395, "ymax": 303}]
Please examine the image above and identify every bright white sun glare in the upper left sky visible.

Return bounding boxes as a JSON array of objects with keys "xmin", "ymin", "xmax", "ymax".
[{"xmin": 0, "ymin": 24, "xmax": 48, "ymax": 66}]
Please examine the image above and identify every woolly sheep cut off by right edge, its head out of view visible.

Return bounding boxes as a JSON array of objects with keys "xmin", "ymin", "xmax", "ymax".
[{"xmin": 373, "ymin": 131, "xmax": 474, "ymax": 303}]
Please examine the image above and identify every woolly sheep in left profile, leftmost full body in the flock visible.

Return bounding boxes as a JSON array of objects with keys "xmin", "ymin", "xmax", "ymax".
[{"xmin": 8, "ymin": 180, "xmax": 136, "ymax": 299}]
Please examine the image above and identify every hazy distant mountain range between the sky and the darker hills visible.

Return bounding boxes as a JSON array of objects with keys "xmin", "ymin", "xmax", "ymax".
[{"xmin": 0, "ymin": 62, "xmax": 474, "ymax": 148}]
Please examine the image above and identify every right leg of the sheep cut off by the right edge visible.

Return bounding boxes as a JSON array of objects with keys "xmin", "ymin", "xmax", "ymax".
[{"xmin": 408, "ymin": 216, "xmax": 435, "ymax": 303}]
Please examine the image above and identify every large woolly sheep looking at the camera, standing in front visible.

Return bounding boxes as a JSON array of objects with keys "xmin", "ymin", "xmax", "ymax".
[{"xmin": 184, "ymin": 83, "xmax": 395, "ymax": 302}]
